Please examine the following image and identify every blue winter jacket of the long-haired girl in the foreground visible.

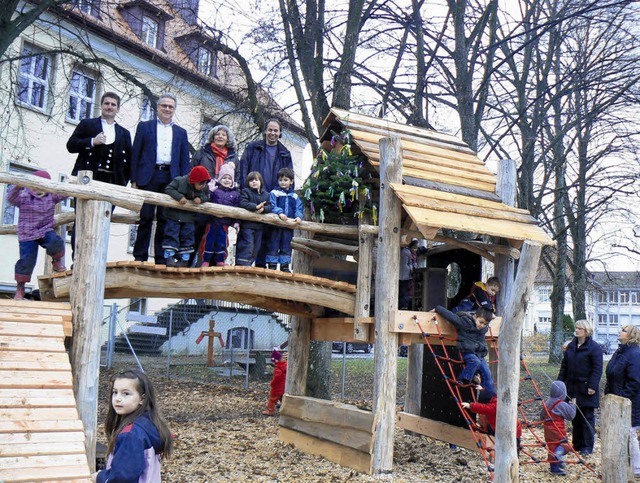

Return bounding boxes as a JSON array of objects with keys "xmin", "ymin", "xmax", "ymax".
[{"xmin": 96, "ymin": 413, "xmax": 162, "ymax": 483}]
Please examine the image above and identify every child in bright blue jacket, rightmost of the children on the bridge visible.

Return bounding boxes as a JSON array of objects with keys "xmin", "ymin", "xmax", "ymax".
[{"xmin": 266, "ymin": 168, "xmax": 304, "ymax": 272}]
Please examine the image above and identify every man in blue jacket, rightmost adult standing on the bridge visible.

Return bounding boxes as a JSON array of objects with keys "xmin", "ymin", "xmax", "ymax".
[{"xmin": 236, "ymin": 118, "xmax": 293, "ymax": 268}]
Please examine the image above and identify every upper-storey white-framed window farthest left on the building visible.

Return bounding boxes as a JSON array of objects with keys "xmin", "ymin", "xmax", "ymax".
[{"xmin": 18, "ymin": 44, "xmax": 53, "ymax": 111}]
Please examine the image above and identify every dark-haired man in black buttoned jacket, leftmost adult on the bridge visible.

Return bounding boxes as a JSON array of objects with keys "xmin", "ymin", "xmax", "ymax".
[{"xmin": 67, "ymin": 92, "xmax": 131, "ymax": 256}]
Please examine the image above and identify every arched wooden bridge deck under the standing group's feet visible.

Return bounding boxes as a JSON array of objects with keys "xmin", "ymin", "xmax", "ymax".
[{"xmin": 38, "ymin": 261, "xmax": 356, "ymax": 317}]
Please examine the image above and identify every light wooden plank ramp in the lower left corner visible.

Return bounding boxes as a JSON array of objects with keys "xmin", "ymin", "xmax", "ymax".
[{"xmin": 0, "ymin": 300, "xmax": 91, "ymax": 483}]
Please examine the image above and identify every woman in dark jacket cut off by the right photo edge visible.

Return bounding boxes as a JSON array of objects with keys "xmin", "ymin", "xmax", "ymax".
[{"xmin": 604, "ymin": 325, "xmax": 640, "ymax": 476}]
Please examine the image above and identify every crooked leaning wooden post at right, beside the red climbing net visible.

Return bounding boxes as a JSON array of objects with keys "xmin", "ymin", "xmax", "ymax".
[{"xmin": 494, "ymin": 241, "xmax": 542, "ymax": 483}]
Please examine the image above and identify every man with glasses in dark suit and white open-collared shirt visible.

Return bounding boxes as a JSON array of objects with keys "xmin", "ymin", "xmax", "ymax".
[{"xmin": 131, "ymin": 94, "xmax": 191, "ymax": 265}]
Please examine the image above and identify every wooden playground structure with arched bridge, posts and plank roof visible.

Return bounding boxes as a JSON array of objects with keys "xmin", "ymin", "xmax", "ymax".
[{"xmin": 0, "ymin": 109, "xmax": 553, "ymax": 481}]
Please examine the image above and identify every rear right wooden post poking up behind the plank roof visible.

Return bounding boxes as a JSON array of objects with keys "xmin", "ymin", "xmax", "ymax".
[{"xmin": 489, "ymin": 159, "xmax": 518, "ymax": 383}]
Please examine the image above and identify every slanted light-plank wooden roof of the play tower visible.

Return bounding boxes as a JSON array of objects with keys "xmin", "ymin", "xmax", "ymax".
[{"xmin": 324, "ymin": 108, "xmax": 553, "ymax": 246}]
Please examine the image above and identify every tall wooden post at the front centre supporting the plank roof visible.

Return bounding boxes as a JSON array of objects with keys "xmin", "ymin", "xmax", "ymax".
[{"xmin": 373, "ymin": 137, "xmax": 402, "ymax": 474}]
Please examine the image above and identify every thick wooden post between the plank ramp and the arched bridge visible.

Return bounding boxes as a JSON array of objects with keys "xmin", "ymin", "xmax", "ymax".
[{"xmin": 70, "ymin": 171, "xmax": 111, "ymax": 472}]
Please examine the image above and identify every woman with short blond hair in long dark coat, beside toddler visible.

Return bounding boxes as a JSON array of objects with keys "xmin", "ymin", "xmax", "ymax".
[{"xmin": 558, "ymin": 320, "xmax": 602, "ymax": 455}]
